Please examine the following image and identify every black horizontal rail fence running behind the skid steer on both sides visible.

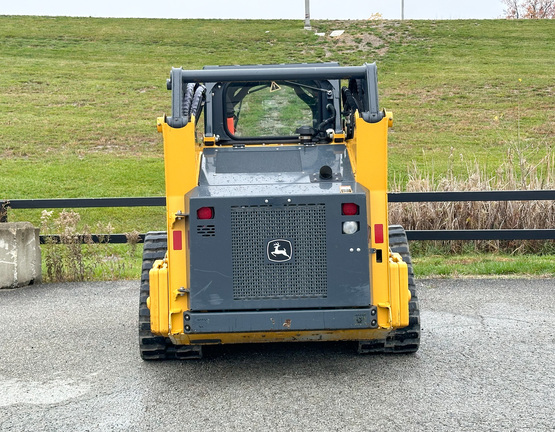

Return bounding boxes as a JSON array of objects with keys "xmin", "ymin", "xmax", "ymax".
[{"xmin": 0, "ymin": 190, "xmax": 555, "ymax": 243}]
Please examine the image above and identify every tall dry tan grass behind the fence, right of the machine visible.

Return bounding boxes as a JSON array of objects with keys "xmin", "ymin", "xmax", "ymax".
[{"xmin": 389, "ymin": 145, "xmax": 555, "ymax": 253}]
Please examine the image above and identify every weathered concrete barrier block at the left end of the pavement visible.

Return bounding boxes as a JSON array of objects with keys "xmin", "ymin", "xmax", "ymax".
[{"xmin": 0, "ymin": 222, "xmax": 42, "ymax": 288}]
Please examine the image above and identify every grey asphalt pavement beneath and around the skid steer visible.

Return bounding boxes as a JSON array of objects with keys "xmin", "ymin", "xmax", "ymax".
[{"xmin": 0, "ymin": 279, "xmax": 555, "ymax": 431}]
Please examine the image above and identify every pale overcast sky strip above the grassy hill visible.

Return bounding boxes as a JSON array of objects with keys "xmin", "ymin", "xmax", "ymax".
[{"xmin": 0, "ymin": 0, "xmax": 503, "ymax": 19}]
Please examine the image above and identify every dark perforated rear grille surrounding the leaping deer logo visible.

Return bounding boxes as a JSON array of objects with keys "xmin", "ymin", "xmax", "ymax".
[{"xmin": 231, "ymin": 204, "xmax": 327, "ymax": 300}]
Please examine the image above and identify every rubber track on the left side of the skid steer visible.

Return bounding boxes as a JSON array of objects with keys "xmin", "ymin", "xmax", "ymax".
[{"xmin": 139, "ymin": 231, "xmax": 202, "ymax": 360}]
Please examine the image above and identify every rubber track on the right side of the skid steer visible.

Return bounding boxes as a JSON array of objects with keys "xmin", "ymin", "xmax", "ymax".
[{"xmin": 358, "ymin": 225, "xmax": 420, "ymax": 354}]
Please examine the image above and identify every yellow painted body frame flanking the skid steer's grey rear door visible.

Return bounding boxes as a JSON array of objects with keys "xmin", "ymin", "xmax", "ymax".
[{"xmin": 147, "ymin": 112, "xmax": 411, "ymax": 345}]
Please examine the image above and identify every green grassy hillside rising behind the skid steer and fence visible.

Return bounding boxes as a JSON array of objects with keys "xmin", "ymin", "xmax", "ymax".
[{"xmin": 0, "ymin": 16, "xmax": 555, "ymax": 236}]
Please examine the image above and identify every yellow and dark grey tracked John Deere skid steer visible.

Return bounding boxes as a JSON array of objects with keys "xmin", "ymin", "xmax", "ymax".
[{"xmin": 139, "ymin": 63, "xmax": 420, "ymax": 360}]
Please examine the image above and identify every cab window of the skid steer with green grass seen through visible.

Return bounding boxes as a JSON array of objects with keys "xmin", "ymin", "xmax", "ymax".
[{"xmin": 225, "ymin": 81, "xmax": 325, "ymax": 138}]
